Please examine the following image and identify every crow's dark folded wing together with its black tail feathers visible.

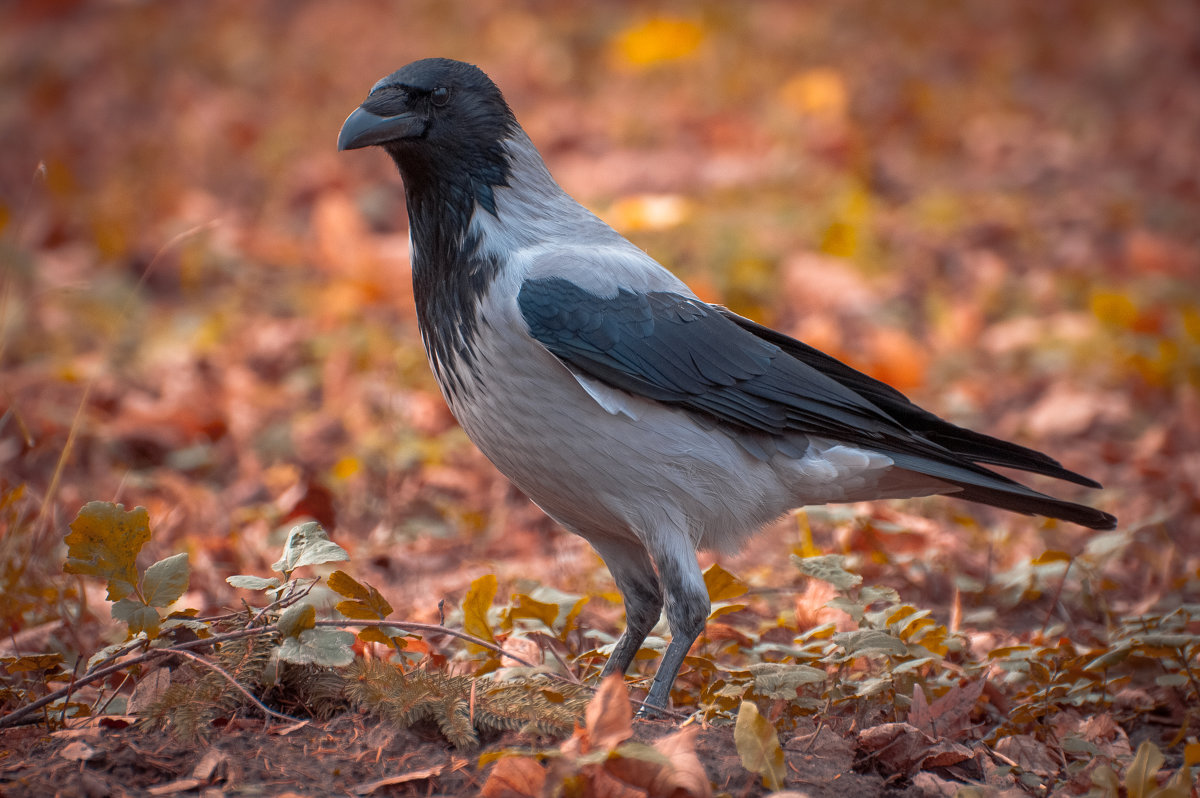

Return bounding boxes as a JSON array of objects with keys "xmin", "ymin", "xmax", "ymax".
[{"xmin": 517, "ymin": 277, "xmax": 1116, "ymax": 529}]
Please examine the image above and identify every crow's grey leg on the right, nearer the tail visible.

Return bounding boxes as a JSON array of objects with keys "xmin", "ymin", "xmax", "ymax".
[{"xmin": 640, "ymin": 535, "xmax": 712, "ymax": 715}]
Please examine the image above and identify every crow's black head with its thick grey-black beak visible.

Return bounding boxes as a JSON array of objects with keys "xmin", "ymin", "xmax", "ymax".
[{"xmin": 337, "ymin": 59, "xmax": 520, "ymax": 202}]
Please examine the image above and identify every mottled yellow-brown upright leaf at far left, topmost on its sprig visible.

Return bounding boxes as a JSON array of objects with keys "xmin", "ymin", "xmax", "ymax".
[{"xmin": 62, "ymin": 502, "xmax": 150, "ymax": 601}]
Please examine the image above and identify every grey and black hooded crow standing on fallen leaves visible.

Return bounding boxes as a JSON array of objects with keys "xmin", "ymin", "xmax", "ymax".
[{"xmin": 337, "ymin": 58, "xmax": 1116, "ymax": 713}]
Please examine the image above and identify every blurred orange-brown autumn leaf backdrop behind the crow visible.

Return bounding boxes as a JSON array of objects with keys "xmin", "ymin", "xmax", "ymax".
[{"xmin": 0, "ymin": 0, "xmax": 1200, "ymax": 646}]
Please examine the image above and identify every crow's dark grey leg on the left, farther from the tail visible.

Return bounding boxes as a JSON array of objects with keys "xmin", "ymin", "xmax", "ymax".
[{"xmin": 592, "ymin": 540, "xmax": 662, "ymax": 678}]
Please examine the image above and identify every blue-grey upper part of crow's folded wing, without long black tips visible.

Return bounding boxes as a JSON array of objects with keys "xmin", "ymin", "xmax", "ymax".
[{"xmin": 517, "ymin": 277, "xmax": 902, "ymax": 445}]
